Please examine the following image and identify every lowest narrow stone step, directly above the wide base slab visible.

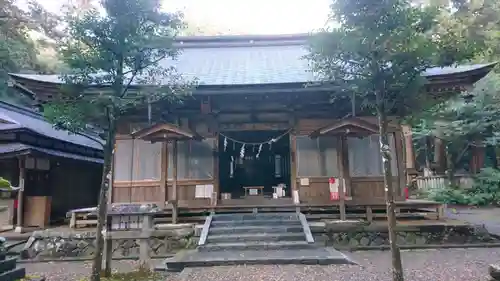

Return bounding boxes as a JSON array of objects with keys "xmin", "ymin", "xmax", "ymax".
[{"xmin": 198, "ymin": 241, "xmax": 308, "ymax": 252}]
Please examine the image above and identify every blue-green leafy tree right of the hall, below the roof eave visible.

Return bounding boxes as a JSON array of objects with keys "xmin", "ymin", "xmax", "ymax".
[{"xmin": 409, "ymin": 70, "xmax": 500, "ymax": 175}]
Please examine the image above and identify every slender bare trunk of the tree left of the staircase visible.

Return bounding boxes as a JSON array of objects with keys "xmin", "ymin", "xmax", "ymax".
[{"xmin": 90, "ymin": 113, "xmax": 116, "ymax": 281}]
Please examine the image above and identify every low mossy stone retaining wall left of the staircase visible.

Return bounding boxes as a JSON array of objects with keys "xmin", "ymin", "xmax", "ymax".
[{"xmin": 21, "ymin": 224, "xmax": 197, "ymax": 259}]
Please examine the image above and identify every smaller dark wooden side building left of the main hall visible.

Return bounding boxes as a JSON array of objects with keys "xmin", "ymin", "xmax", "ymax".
[{"xmin": 0, "ymin": 102, "xmax": 103, "ymax": 229}]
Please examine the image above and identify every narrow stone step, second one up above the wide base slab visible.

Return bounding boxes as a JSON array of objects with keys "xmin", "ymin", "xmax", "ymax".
[{"xmin": 207, "ymin": 232, "xmax": 305, "ymax": 243}]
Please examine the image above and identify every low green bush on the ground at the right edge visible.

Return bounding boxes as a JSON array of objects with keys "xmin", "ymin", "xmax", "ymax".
[{"xmin": 427, "ymin": 168, "xmax": 500, "ymax": 206}]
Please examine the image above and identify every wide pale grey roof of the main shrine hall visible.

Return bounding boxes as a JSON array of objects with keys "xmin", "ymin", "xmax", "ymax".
[{"xmin": 6, "ymin": 35, "xmax": 496, "ymax": 85}]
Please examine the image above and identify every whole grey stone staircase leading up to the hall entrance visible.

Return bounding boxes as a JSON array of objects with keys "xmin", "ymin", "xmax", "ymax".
[{"xmin": 158, "ymin": 212, "xmax": 353, "ymax": 271}]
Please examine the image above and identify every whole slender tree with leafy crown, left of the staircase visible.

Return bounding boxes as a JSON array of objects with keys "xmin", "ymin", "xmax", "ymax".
[{"xmin": 44, "ymin": 0, "xmax": 193, "ymax": 281}]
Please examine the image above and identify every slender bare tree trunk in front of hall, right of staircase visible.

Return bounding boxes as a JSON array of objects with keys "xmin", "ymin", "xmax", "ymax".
[{"xmin": 377, "ymin": 103, "xmax": 404, "ymax": 281}]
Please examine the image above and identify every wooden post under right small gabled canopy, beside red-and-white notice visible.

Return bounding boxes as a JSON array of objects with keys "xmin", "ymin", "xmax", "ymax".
[{"xmin": 337, "ymin": 135, "xmax": 351, "ymax": 220}]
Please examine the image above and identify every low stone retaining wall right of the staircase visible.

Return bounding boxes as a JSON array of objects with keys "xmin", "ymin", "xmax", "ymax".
[{"xmin": 315, "ymin": 221, "xmax": 500, "ymax": 249}]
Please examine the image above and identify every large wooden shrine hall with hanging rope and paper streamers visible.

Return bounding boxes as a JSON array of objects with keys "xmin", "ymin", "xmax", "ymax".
[{"xmin": 11, "ymin": 34, "xmax": 494, "ymax": 221}]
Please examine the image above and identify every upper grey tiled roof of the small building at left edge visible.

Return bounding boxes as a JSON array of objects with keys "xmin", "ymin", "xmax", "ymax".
[{"xmin": 0, "ymin": 102, "xmax": 102, "ymax": 150}]
